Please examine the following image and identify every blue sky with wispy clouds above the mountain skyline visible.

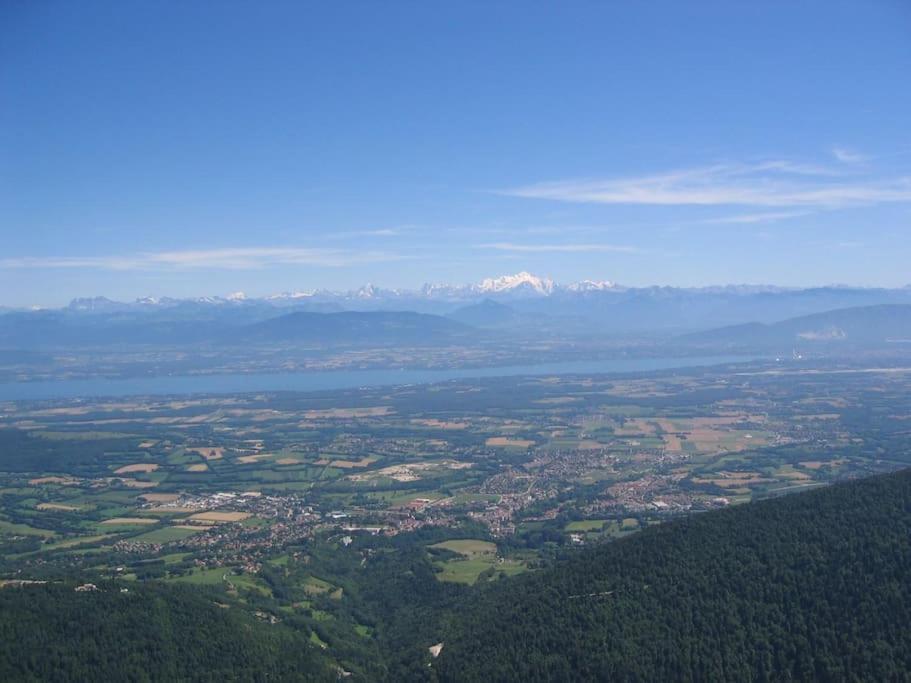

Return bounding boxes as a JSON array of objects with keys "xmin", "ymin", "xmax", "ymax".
[{"xmin": 0, "ymin": 0, "xmax": 911, "ymax": 305}]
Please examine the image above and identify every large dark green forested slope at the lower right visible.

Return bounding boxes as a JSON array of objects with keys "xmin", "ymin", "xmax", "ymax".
[{"xmin": 433, "ymin": 471, "xmax": 911, "ymax": 681}]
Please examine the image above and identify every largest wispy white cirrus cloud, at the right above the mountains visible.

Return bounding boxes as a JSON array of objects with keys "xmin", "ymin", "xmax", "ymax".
[{"xmin": 500, "ymin": 161, "xmax": 911, "ymax": 209}]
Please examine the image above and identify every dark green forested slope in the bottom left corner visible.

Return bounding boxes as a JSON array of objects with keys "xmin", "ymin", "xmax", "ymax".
[{"xmin": 0, "ymin": 582, "xmax": 338, "ymax": 681}]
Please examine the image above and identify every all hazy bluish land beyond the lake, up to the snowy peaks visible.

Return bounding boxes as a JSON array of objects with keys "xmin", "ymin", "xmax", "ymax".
[{"xmin": 0, "ymin": 272, "xmax": 911, "ymax": 390}]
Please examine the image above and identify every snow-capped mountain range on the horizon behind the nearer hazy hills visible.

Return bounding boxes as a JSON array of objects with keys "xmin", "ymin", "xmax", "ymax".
[{"xmin": 48, "ymin": 271, "xmax": 911, "ymax": 335}]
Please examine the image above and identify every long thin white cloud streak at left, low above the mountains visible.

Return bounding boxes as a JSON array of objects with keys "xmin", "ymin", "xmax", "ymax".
[{"xmin": 0, "ymin": 247, "xmax": 404, "ymax": 270}]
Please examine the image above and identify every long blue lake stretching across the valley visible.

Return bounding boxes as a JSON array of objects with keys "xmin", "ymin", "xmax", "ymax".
[{"xmin": 0, "ymin": 356, "xmax": 755, "ymax": 401}]
